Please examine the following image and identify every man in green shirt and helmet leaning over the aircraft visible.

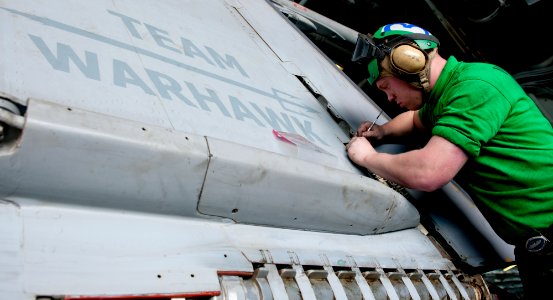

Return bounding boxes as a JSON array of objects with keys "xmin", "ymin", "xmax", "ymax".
[{"xmin": 346, "ymin": 23, "xmax": 553, "ymax": 299}]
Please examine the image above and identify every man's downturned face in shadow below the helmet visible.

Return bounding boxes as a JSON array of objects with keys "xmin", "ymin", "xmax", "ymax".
[{"xmin": 376, "ymin": 76, "xmax": 422, "ymax": 110}]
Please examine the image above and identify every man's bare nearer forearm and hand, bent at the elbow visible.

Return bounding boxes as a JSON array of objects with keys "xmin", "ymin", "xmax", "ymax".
[{"xmin": 346, "ymin": 136, "xmax": 468, "ymax": 191}]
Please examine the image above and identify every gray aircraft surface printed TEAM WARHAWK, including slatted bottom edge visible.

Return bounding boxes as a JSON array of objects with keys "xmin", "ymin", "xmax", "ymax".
[{"xmin": 0, "ymin": 0, "xmax": 548, "ymax": 300}]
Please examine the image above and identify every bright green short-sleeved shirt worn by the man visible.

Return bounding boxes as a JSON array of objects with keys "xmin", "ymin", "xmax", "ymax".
[{"xmin": 419, "ymin": 57, "xmax": 553, "ymax": 243}]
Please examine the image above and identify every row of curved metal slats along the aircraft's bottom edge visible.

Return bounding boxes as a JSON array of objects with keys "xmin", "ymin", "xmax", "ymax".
[{"xmin": 216, "ymin": 264, "xmax": 489, "ymax": 300}]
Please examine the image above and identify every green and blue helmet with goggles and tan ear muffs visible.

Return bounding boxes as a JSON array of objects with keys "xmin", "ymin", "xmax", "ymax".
[{"xmin": 353, "ymin": 23, "xmax": 439, "ymax": 92}]
